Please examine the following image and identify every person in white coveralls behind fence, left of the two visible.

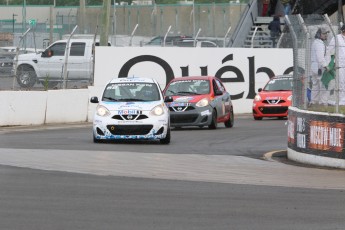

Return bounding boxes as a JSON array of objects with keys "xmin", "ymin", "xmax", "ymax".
[{"xmin": 310, "ymin": 27, "xmax": 329, "ymax": 105}]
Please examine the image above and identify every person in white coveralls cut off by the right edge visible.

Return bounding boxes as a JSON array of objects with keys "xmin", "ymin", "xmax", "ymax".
[{"xmin": 327, "ymin": 25, "xmax": 345, "ymax": 105}]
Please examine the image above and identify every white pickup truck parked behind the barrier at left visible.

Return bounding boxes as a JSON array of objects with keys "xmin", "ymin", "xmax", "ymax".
[{"xmin": 14, "ymin": 39, "xmax": 98, "ymax": 88}]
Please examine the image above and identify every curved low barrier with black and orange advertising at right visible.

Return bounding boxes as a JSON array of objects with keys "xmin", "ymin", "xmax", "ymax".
[{"xmin": 287, "ymin": 107, "xmax": 345, "ymax": 168}]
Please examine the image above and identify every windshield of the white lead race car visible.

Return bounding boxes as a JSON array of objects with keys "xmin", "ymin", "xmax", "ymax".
[{"xmin": 102, "ymin": 82, "xmax": 160, "ymax": 102}]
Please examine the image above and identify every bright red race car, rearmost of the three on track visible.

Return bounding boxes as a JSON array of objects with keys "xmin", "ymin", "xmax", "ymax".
[{"xmin": 253, "ymin": 75, "xmax": 293, "ymax": 120}]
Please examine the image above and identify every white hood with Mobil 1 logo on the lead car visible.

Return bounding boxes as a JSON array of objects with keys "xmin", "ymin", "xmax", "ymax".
[{"xmin": 100, "ymin": 101, "xmax": 164, "ymax": 111}]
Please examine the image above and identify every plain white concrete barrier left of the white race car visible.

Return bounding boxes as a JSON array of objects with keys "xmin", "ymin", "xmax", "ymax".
[{"xmin": 0, "ymin": 89, "xmax": 91, "ymax": 126}]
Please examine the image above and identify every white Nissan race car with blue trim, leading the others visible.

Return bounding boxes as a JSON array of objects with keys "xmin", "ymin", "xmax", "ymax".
[{"xmin": 90, "ymin": 77, "xmax": 170, "ymax": 144}]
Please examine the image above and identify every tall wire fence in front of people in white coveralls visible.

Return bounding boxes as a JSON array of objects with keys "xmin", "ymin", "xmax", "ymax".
[{"xmin": 285, "ymin": 15, "xmax": 345, "ymax": 114}]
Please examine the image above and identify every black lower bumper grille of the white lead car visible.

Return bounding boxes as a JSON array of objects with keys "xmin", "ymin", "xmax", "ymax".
[{"xmin": 107, "ymin": 125, "xmax": 153, "ymax": 135}]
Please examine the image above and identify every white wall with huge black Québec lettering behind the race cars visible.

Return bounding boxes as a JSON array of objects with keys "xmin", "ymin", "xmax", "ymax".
[{"xmin": 95, "ymin": 47, "xmax": 293, "ymax": 113}]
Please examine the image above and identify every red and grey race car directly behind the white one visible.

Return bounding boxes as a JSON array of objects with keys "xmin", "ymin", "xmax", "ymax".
[{"xmin": 164, "ymin": 76, "xmax": 234, "ymax": 129}]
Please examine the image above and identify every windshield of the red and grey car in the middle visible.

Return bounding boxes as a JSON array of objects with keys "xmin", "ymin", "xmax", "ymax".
[{"xmin": 165, "ymin": 80, "xmax": 210, "ymax": 96}]
